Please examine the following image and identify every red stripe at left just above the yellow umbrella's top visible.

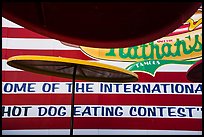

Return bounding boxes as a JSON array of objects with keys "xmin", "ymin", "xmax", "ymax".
[{"xmin": 2, "ymin": 49, "xmax": 93, "ymax": 60}]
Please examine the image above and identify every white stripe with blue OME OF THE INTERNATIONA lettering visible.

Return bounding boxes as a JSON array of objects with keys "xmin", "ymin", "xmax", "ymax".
[{"xmin": 2, "ymin": 81, "xmax": 202, "ymax": 95}]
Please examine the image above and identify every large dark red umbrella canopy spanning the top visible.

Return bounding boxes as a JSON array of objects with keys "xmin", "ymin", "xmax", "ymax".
[{"xmin": 2, "ymin": 1, "xmax": 201, "ymax": 48}]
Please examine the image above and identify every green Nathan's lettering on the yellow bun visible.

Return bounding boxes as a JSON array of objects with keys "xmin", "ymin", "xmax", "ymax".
[{"xmin": 105, "ymin": 33, "xmax": 202, "ymax": 60}]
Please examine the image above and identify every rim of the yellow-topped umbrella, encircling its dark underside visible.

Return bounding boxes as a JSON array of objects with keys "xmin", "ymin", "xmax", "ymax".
[{"xmin": 7, "ymin": 55, "xmax": 138, "ymax": 82}]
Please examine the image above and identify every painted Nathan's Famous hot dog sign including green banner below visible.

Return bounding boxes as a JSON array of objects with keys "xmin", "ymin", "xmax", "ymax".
[{"xmin": 80, "ymin": 8, "xmax": 202, "ymax": 75}]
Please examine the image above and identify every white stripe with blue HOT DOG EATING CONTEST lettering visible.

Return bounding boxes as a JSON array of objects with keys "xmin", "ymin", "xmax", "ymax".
[{"xmin": 2, "ymin": 105, "xmax": 202, "ymax": 119}]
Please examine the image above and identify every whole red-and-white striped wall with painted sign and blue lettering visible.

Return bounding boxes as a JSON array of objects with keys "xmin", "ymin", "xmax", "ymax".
[{"xmin": 2, "ymin": 7, "xmax": 202, "ymax": 135}]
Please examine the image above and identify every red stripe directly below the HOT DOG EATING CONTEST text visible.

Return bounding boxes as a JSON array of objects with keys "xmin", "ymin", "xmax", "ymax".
[{"xmin": 2, "ymin": 117, "xmax": 202, "ymax": 131}]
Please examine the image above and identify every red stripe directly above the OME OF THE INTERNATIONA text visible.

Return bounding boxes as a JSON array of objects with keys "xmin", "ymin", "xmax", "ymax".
[{"xmin": 2, "ymin": 71, "xmax": 190, "ymax": 82}]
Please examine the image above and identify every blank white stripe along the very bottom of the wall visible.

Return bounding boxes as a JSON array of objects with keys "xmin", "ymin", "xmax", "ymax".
[{"xmin": 2, "ymin": 129, "xmax": 202, "ymax": 135}]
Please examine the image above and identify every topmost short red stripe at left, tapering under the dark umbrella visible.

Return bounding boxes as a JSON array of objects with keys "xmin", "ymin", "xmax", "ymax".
[{"xmin": 2, "ymin": 27, "xmax": 50, "ymax": 39}]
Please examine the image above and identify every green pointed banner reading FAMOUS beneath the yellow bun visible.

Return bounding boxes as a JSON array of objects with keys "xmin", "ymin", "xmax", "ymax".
[{"xmin": 126, "ymin": 60, "xmax": 196, "ymax": 76}]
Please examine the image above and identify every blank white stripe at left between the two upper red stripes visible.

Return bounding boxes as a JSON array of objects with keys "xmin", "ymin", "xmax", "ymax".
[{"xmin": 2, "ymin": 38, "xmax": 80, "ymax": 50}]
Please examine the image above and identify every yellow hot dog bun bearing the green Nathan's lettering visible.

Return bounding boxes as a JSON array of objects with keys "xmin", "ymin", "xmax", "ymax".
[{"xmin": 80, "ymin": 28, "xmax": 202, "ymax": 62}]
